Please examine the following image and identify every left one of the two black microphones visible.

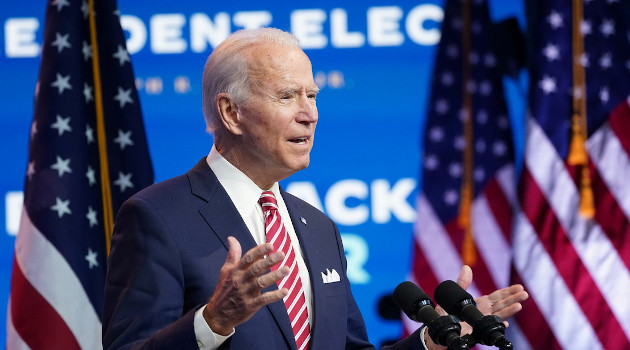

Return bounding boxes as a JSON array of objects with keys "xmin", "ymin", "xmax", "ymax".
[{"xmin": 393, "ymin": 281, "xmax": 474, "ymax": 350}]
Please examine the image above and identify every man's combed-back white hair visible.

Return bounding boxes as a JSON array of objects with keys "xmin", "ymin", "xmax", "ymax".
[{"xmin": 202, "ymin": 28, "xmax": 300, "ymax": 132}]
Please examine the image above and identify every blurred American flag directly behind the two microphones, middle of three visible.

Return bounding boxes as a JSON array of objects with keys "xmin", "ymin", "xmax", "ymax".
[{"xmin": 403, "ymin": 0, "xmax": 516, "ymax": 344}]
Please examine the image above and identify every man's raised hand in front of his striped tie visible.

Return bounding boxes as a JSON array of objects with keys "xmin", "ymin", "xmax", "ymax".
[{"xmin": 203, "ymin": 237, "xmax": 289, "ymax": 335}]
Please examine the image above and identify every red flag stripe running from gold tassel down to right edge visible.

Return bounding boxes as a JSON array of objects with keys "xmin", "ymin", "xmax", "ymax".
[{"xmin": 589, "ymin": 162, "xmax": 630, "ymax": 269}]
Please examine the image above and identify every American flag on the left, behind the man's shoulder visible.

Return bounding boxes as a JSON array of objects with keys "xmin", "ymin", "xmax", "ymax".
[{"xmin": 7, "ymin": 0, "xmax": 153, "ymax": 350}]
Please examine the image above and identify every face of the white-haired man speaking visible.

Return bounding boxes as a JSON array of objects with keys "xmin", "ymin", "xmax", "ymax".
[{"xmin": 238, "ymin": 44, "xmax": 318, "ymax": 183}]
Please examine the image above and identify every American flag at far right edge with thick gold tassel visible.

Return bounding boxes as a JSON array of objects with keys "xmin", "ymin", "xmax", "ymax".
[{"xmin": 513, "ymin": 0, "xmax": 630, "ymax": 350}]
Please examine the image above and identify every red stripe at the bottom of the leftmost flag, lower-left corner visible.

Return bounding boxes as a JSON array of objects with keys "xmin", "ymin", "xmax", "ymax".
[{"xmin": 11, "ymin": 257, "xmax": 81, "ymax": 350}]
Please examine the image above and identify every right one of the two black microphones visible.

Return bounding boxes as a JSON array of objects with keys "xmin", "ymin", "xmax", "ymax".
[{"xmin": 434, "ymin": 280, "xmax": 512, "ymax": 350}]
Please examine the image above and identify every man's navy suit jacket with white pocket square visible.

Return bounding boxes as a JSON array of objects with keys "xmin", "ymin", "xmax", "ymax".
[{"xmin": 103, "ymin": 158, "xmax": 422, "ymax": 350}]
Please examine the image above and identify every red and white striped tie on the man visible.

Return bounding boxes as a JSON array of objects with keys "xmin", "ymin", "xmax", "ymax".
[{"xmin": 258, "ymin": 191, "xmax": 311, "ymax": 350}]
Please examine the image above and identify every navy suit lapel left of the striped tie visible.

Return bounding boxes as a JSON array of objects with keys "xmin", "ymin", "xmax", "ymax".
[{"xmin": 187, "ymin": 158, "xmax": 297, "ymax": 350}]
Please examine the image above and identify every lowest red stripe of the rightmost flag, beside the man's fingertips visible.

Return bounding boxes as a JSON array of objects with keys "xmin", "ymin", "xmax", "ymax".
[{"xmin": 511, "ymin": 266, "xmax": 562, "ymax": 350}]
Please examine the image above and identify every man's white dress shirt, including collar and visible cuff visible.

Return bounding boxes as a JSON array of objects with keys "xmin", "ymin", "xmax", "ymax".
[{"xmin": 194, "ymin": 146, "xmax": 313, "ymax": 350}]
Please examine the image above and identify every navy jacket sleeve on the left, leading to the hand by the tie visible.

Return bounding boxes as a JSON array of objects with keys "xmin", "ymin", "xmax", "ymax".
[{"xmin": 103, "ymin": 198, "xmax": 198, "ymax": 350}]
